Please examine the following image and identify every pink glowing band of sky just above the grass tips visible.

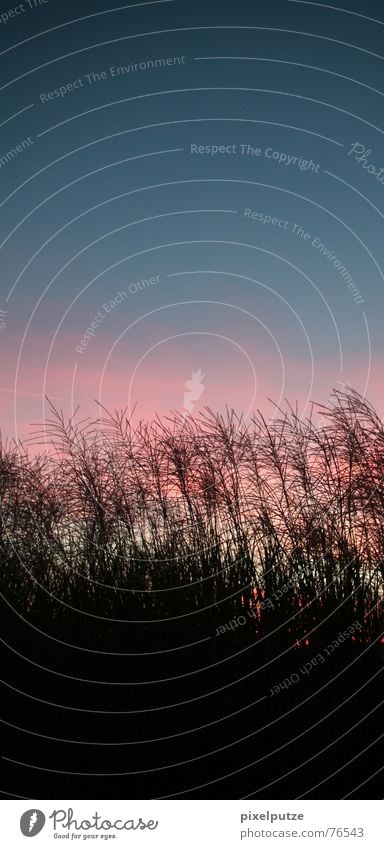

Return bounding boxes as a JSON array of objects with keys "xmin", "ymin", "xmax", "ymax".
[{"xmin": 0, "ymin": 334, "xmax": 384, "ymax": 448}]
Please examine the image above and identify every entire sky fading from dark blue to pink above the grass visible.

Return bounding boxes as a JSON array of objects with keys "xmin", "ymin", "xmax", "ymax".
[{"xmin": 0, "ymin": 0, "xmax": 384, "ymax": 439}]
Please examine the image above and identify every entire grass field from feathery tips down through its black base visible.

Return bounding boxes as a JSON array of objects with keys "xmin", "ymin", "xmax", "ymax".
[{"xmin": 0, "ymin": 390, "xmax": 384, "ymax": 798}]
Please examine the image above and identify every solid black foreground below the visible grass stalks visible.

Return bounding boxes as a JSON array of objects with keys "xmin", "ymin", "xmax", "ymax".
[{"xmin": 1, "ymin": 605, "xmax": 383, "ymax": 800}]
